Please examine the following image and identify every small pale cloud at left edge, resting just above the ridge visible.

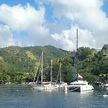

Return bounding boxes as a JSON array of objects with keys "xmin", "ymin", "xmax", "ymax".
[{"xmin": 0, "ymin": 25, "xmax": 15, "ymax": 47}]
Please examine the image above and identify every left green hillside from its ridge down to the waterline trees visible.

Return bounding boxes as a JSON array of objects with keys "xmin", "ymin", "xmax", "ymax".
[{"xmin": 0, "ymin": 46, "xmax": 66, "ymax": 83}]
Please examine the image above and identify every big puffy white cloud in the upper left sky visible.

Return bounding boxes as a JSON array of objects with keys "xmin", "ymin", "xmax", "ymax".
[{"xmin": 0, "ymin": 4, "xmax": 44, "ymax": 31}]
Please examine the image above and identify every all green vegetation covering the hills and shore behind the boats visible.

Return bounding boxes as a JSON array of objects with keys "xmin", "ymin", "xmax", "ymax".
[{"xmin": 0, "ymin": 45, "xmax": 108, "ymax": 84}]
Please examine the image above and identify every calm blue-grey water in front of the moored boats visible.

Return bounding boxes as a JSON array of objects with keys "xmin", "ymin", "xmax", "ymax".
[{"xmin": 0, "ymin": 85, "xmax": 108, "ymax": 108}]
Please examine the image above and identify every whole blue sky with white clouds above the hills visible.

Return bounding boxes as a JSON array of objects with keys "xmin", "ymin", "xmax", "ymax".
[{"xmin": 0, "ymin": 0, "xmax": 108, "ymax": 51}]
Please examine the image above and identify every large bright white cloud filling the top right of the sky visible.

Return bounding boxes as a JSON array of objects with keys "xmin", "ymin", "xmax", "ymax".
[{"xmin": 44, "ymin": 0, "xmax": 108, "ymax": 30}]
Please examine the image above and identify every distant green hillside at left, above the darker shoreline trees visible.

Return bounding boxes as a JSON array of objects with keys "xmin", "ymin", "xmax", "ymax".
[{"xmin": 0, "ymin": 46, "xmax": 66, "ymax": 72}]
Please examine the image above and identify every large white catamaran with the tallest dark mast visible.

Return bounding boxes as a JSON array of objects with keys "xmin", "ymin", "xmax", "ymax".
[{"xmin": 67, "ymin": 29, "xmax": 94, "ymax": 92}]
